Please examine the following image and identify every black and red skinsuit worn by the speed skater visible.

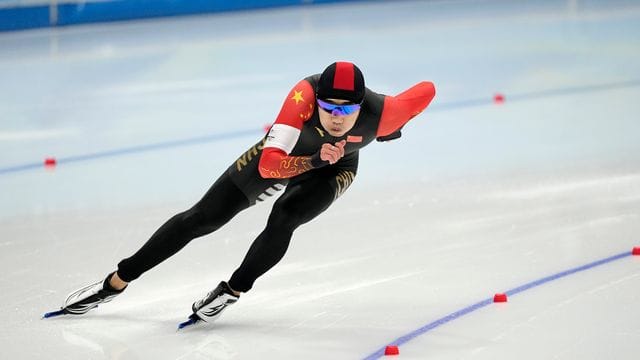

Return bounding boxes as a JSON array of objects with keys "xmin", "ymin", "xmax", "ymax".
[{"xmin": 118, "ymin": 74, "xmax": 435, "ymax": 292}]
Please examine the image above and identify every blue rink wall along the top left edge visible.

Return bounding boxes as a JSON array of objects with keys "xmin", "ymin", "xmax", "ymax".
[{"xmin": 0, "ymin": 0, "xmax": 368, "ymax": 31}]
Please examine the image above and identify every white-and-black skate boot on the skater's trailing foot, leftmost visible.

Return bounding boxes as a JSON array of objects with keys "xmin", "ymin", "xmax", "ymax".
[{"xmin": 62, "ymin": 273, "xmax": 126, "ymax": 315}]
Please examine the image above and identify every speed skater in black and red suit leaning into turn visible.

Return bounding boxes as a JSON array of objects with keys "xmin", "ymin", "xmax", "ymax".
[{"xmin": 53, "ymin": 62, "xmax": 435, "ymax": 322}]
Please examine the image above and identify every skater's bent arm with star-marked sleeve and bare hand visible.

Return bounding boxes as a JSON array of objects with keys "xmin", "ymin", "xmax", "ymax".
[{"xmin": 258, "ymin": 80, "xmax": 344, "ymax": 179}]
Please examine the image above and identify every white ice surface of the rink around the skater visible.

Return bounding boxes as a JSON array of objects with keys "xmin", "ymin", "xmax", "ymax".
[{"xmin": 0, "ymin": 0, "xmax": 640, "ymax": 360}]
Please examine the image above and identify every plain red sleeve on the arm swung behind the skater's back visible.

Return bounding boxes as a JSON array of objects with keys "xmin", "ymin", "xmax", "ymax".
[{"xmin": 376, "ymin": 81, "xmax": 436, "ymax": 137}]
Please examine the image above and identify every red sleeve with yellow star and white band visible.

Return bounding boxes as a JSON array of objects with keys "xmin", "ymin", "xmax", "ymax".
[{"xmin": 258, "ymin": 80, "xmax": 316, "ymax": 179}]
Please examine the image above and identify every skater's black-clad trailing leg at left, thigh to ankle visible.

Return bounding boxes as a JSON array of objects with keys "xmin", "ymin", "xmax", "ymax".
[{"xmin": 118, "ymin": 173, "xmax": 250, "ymax": 282}]
